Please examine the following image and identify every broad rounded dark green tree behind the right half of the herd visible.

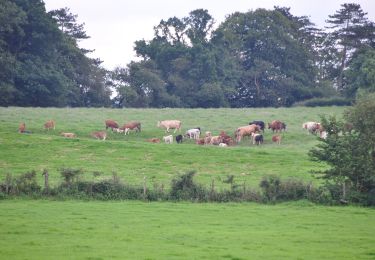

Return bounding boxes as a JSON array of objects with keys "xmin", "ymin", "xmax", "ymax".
[{"xmin": 213, "ymin": 8, "xmax": 316, "ymax": 107}]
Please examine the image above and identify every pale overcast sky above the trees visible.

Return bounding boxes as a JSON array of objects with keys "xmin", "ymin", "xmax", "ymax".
[{"xmin": 44, "ymin": 0, "xmax": 375, "ymax": 69}]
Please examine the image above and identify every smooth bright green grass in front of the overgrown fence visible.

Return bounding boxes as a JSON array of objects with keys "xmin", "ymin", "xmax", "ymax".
[{"xmin": 0, "ymin": 200, "xmax": 375, "ymax": 259}]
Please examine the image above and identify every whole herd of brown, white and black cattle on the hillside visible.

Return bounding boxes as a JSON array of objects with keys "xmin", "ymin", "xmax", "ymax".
[{"xmin": 18, "ymin": 119, "xmax": 327, "ymax": 147}]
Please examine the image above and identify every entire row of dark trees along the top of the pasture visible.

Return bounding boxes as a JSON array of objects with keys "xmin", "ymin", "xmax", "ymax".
[{"xmin": 0, "ymin": 0, "xmax": 375, "ymax": 108}]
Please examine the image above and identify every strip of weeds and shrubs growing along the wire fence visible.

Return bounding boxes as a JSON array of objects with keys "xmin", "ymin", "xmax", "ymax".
[{"xmin": 0, "ymin": 168, "xmax": 334, "ymax": 203}]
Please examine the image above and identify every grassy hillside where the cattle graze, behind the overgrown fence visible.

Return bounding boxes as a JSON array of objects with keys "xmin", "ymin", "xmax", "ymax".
[{"xmin": 0, "ymin": 107, "xmax": 344, "ymax": 189}]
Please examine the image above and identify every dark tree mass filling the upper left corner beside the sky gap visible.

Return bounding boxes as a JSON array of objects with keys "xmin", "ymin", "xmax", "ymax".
[{"xmin": 0, "ymin": 0, "xmax": 110, "ymax": 106}]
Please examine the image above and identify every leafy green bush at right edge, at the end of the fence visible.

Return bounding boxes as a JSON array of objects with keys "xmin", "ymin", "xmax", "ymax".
[{"xmin": 310, "ymin": 94, "xmax": 375, "ymax": 205}]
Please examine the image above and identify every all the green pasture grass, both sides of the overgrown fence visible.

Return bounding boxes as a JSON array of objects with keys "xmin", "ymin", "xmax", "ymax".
[{"xmin": 0, "ymin": 107, "xmax": 375, "ymax": 259}]
